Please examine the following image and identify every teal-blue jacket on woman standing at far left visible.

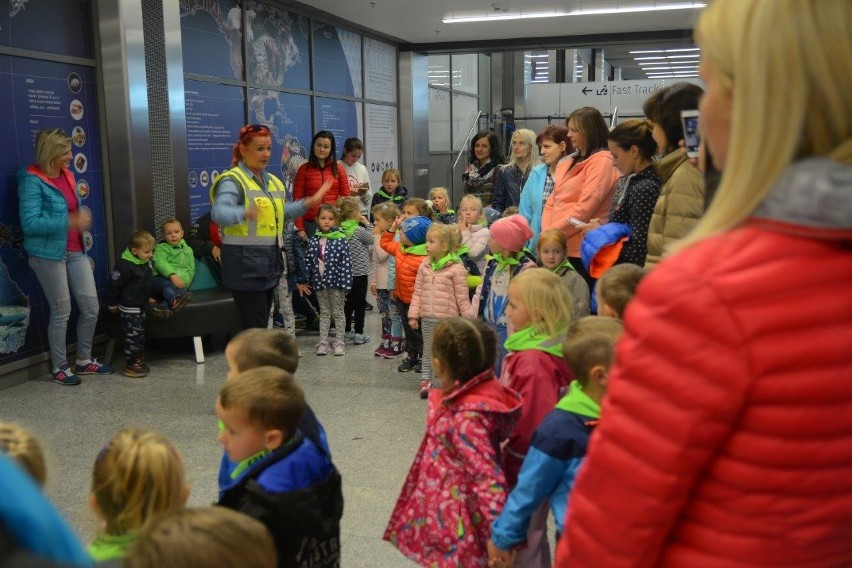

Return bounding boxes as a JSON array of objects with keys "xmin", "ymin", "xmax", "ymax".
[{"xmin": 18, "ymin": 166, "xmax": 80, "ymax": 260}]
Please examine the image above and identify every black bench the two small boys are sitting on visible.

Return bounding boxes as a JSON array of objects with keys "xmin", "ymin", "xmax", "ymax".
[{"xmin": 104, "ymin": 258, "xmax": 242, "ymax": 363}]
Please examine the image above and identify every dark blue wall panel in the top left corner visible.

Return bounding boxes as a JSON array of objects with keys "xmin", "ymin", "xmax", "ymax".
[{"xmin": 0, "ymin": 0, "xmax": 93, "ymax": 58}]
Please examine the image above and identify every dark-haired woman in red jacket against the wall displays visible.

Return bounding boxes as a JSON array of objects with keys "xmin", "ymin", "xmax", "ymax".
[{"xmin": 293, "ymin": 130, "xmax": 351, "ymax": 242}]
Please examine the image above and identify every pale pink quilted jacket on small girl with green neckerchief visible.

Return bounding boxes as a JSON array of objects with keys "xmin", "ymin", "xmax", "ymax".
[{"xmin": 408, "ymin": 259, "xmax": 470, "ymax": 319}]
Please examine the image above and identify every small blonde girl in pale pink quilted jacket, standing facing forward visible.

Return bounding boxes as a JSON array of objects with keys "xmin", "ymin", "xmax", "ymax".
[{"xmin": 408, "ymin": 223, "xmax": 470, "ymax": 398}]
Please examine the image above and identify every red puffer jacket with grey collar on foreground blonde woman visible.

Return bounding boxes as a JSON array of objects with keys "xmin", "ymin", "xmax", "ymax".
[{"xmin": 557, "ymin": 160, "xmax": 852, "ymax": 568}]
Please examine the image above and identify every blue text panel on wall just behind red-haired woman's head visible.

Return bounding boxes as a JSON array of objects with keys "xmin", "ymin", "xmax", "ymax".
[{"xmin": 184, "ymin": 80, "xmax": 245, "ymax": 220}]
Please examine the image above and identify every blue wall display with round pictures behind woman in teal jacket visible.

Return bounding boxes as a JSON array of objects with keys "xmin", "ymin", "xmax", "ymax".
[{"xmin": 0, "ymin": 54, "xmax": 108, "ymax": 366}]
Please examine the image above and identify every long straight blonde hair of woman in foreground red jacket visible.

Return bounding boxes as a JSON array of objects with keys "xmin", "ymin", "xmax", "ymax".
[{"xmin": 675, "ymin": 0, "xmax": 852, "ymax": 248}]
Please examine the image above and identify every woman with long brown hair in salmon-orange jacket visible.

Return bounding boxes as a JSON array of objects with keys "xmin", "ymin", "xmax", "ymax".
[{"xmin": 541, "ymin": 107, "xmax": 618, "ymax": 289}]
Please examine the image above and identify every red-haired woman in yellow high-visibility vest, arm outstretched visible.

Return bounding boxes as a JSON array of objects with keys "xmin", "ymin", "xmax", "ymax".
[{"xmin": 210, "ymin": 124, "xmax": 332, "ymax": 329}]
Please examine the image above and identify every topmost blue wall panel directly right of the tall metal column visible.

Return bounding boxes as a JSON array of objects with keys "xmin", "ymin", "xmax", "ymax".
[{"xmin": 180, "ymin": 0, "xmax": 244, "ymax": 79}]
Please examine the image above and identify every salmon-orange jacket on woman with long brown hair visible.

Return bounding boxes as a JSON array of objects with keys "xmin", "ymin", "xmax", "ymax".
[{"xmin": 541, "ymin": 150, "xmax": 619, "ymax": 258}]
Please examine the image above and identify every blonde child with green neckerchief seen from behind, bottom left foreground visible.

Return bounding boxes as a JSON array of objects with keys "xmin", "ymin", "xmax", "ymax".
[{"xmin": 89, "ymin": 428, "xmax": 189, "ymax": 562}]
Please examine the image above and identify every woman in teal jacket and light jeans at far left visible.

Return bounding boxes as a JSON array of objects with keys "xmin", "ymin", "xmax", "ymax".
[{"xmin": 18, "ymin": 128, "xmax": 113, "ymax": 386}]
